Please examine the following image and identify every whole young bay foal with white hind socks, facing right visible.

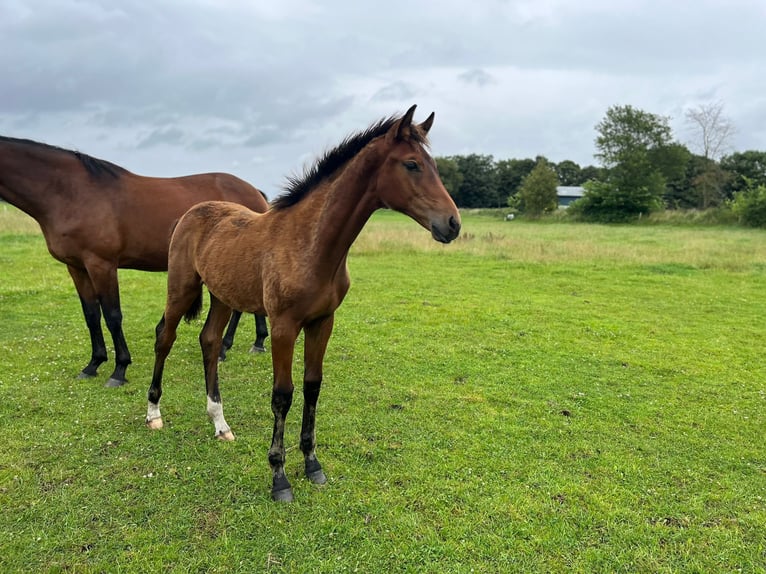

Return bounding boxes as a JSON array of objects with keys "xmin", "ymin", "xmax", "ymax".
[{"xmin": 146, "ymin": 106, "xmax": 460, "ymax": 501}]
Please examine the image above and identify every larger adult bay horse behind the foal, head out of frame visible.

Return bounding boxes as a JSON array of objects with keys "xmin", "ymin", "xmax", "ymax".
[{"xmin": 0, "ymin": 136, "xmax": 268, "ymax": 387}]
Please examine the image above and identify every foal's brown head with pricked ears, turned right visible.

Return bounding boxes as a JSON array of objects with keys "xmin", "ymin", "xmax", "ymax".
[{"xmin": 377, "ymin": 106, "xmax": 460, "ymax": 243}]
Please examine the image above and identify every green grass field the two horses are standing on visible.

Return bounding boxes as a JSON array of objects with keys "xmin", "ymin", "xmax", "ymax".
[{"xmin": 0, "ymin": 206, "xmax": 766, "ymax": 573}]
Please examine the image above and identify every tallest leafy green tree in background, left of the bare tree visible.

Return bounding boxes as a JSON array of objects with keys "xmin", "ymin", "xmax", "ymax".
[{"xmin": 574, "ymin": 105, "xmax": 672, "ymax": 221}]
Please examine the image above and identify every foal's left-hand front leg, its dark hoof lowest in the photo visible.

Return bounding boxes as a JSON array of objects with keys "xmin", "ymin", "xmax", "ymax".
[{"xmin": 269, "ymin": 318, "xmax": 300, "ymax": 502}]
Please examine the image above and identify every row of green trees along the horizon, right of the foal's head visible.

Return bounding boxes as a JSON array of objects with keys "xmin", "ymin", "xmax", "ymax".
[{"xmin": 436, "ymin": 103, "xmax": 766, "ymax": 226}]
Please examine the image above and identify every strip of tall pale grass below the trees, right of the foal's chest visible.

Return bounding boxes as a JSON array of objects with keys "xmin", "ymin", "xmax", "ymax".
[{"xmin": 353, "ymin": 213, "xmax": 766, "ymax": 271}]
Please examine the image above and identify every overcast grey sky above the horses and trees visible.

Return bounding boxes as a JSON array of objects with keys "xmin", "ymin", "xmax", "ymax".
[{"xmin": 0, "ymin": 0, "xmax": 766, "ymax": 198}]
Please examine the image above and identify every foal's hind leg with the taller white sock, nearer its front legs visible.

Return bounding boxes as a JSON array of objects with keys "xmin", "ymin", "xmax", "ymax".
[{"xmin": 199, "ymin": 293, "xmax": 234, "ymax": 440}]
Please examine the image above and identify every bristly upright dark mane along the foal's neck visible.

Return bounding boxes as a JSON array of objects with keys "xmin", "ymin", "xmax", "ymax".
[{"xmin": 271, "ymin": 112, "xmax": 428, "ymax": 210}]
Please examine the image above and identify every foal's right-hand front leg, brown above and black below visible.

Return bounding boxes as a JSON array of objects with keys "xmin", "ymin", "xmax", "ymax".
[{"xmin": 301, "ymin": 315, "xmax": 334, "ymax": 484}]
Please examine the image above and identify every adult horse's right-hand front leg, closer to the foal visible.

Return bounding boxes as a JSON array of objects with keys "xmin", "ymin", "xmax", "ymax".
[{"xmin": 85, "ymin": 259, "xmax": 132, "ymax": 387}]
